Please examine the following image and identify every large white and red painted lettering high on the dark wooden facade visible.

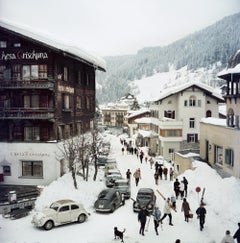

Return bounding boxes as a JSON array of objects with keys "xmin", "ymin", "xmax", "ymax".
[{"xmin": 0, "ymin": 50, "xmax": 48, "ymax": 61}]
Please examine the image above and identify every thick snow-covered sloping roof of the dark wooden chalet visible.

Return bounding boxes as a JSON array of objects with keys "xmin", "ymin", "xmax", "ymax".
[{"xmin": 0, "ymin": 19, "xmax": 106, "ymax": 71}]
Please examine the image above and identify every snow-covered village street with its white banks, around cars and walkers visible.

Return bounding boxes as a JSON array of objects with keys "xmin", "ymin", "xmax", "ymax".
[{"xmin": 0, "ymin": 131, "xmax": 240, "ymax": 243}]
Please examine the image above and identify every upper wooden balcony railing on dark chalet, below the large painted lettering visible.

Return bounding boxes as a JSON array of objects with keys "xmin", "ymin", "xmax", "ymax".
[{"xmin": 0, "ymin": 78, "xmax": 54, "ymax": 89}]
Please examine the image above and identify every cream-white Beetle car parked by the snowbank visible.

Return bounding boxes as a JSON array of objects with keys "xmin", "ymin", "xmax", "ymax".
[{"xmin": 32, "ymin": 199, "xmax": 90, "ymax": 230}]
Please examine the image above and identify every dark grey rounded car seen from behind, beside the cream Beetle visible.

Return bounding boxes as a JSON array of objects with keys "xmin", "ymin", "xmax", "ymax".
[{"xmin": 94, "ymin": 188, "xmax": 125, "ymax": 213}]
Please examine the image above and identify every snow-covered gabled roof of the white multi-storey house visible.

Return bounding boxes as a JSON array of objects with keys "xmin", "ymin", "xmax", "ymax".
[{"xmin": 156, "ymin": 82, "xmax": 224, "ymax": 102}]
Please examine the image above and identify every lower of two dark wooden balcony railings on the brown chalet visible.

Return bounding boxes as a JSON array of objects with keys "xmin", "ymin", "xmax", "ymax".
[{"xmin": 0, "ymin": 107, "xmax": 54, "ymax": 120}]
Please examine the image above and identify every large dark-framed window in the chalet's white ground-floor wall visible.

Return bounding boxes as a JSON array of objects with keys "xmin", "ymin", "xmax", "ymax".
[{"xmin": 22, "ymin": 161, "xmax": 43, "ymax": 177}]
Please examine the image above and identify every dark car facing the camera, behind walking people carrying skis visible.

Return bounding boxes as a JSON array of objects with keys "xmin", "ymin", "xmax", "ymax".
[{"xmin": 133, "ymin": 188, "xmax": 156, "ymax": 212}]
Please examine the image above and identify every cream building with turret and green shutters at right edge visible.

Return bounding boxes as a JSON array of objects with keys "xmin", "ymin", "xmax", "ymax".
[{"xmin": 200, "ymin": 51, "xmax": 240, "ymax": 178}]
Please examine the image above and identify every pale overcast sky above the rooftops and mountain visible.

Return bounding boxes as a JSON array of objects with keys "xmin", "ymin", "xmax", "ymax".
[{"xmin": 0, "ymin": 0, "xmax": 240, "ymax": 56}]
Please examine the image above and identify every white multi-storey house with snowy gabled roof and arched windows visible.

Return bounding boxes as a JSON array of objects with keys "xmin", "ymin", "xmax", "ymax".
[{"xmin": 149, "ymin": 82, "xmax": 224, "ymax": 160}]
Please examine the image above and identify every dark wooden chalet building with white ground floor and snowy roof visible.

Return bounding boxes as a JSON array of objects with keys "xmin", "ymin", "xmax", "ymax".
[{"xmin": 0, "ymin": 22, "xmax": 105, "ymax": 185}]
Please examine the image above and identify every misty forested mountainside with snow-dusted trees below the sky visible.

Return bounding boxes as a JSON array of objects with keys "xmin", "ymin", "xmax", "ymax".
[{"xmin": 97, "ymin": 13, "xmax": 240, "ymax": 103}]
